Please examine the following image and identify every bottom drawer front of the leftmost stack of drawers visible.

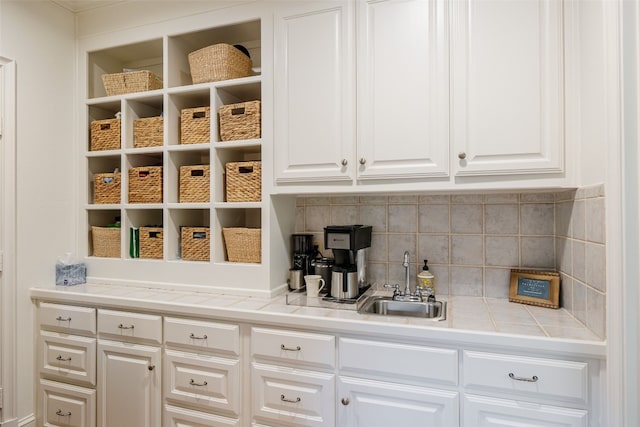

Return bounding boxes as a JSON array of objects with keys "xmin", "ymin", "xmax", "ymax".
[{"xmin": 40, "ymin": 380, "xmax": 96, "ymax": 427}]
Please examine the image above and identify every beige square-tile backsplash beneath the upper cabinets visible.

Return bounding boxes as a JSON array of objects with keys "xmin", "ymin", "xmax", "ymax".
[{"xmin": 295, "ymin": 186, "xmax": 606, "ymax": 338}]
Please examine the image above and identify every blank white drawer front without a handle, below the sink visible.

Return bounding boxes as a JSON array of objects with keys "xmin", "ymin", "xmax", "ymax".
[{"xmin": 338, "ymin": 338, "xmax": 458, "ymax": 385}]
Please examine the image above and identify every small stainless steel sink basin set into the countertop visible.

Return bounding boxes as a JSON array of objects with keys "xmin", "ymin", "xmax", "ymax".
[{"xmin": 358, "ymin": 296, "xmax": 447, "ymax": 321}]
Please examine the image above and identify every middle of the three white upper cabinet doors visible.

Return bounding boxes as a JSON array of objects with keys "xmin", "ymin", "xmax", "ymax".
[{"xmin": 357, "ymin": 0, "xmax": 449, "ymax": 179}]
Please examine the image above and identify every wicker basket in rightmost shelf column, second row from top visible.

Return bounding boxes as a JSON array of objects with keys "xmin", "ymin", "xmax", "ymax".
[{"xmin": 218, "ymin": 101, "xmax": 261, "ymax": 141}]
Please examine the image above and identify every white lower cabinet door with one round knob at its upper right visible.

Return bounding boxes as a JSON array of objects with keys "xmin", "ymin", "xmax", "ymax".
[{"xmin": 98, "ymin": 340, "xmax": 162, "ymax": 427}]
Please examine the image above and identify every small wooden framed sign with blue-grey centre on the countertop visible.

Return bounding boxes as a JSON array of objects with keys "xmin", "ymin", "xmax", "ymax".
[{"xmin": 509, "ymin": 269, "xmax": 560, "ymax": 308}]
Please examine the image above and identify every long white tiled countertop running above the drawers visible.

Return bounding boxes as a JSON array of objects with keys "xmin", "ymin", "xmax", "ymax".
[{"xmin": 30, "ymin": 284, "xmax": 606, "ymax": 358}]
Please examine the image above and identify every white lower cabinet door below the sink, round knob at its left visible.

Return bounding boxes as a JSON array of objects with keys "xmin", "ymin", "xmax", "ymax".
[{"xmin": 337, "ymin": 377, "xmax": 458, "ymax": 427}]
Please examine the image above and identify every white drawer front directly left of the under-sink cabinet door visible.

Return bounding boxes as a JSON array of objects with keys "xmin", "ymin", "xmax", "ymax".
[{"xmin": 252, "ymin": 363, "xmax": 335, "ymax": 427}]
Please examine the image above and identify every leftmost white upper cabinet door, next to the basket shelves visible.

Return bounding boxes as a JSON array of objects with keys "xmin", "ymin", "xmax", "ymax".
[{"xmin": 274, "ymin": 0, "xmax": 355, "ymax": 183}]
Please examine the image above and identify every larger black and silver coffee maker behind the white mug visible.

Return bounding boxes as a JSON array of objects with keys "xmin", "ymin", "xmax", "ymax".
[{"xmin": 324, "ymin": 224, "xmax": 372, "ymax": 300}]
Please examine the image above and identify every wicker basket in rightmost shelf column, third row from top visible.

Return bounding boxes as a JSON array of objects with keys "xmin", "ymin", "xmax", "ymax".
[{"xmin": 226, "ymin": 161, "xmax": 262, "ymax": 202}]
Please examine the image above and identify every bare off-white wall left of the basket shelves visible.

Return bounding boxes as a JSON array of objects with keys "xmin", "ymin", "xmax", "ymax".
[{"xmin": 0, "ymin": 0, "xmax": 77, "ymax": 423}]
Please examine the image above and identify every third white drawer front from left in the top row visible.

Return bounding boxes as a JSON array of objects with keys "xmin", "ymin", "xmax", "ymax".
[{"xmin": 164, "ymin": 317, "xmax": 240, "ymax": 356}]
